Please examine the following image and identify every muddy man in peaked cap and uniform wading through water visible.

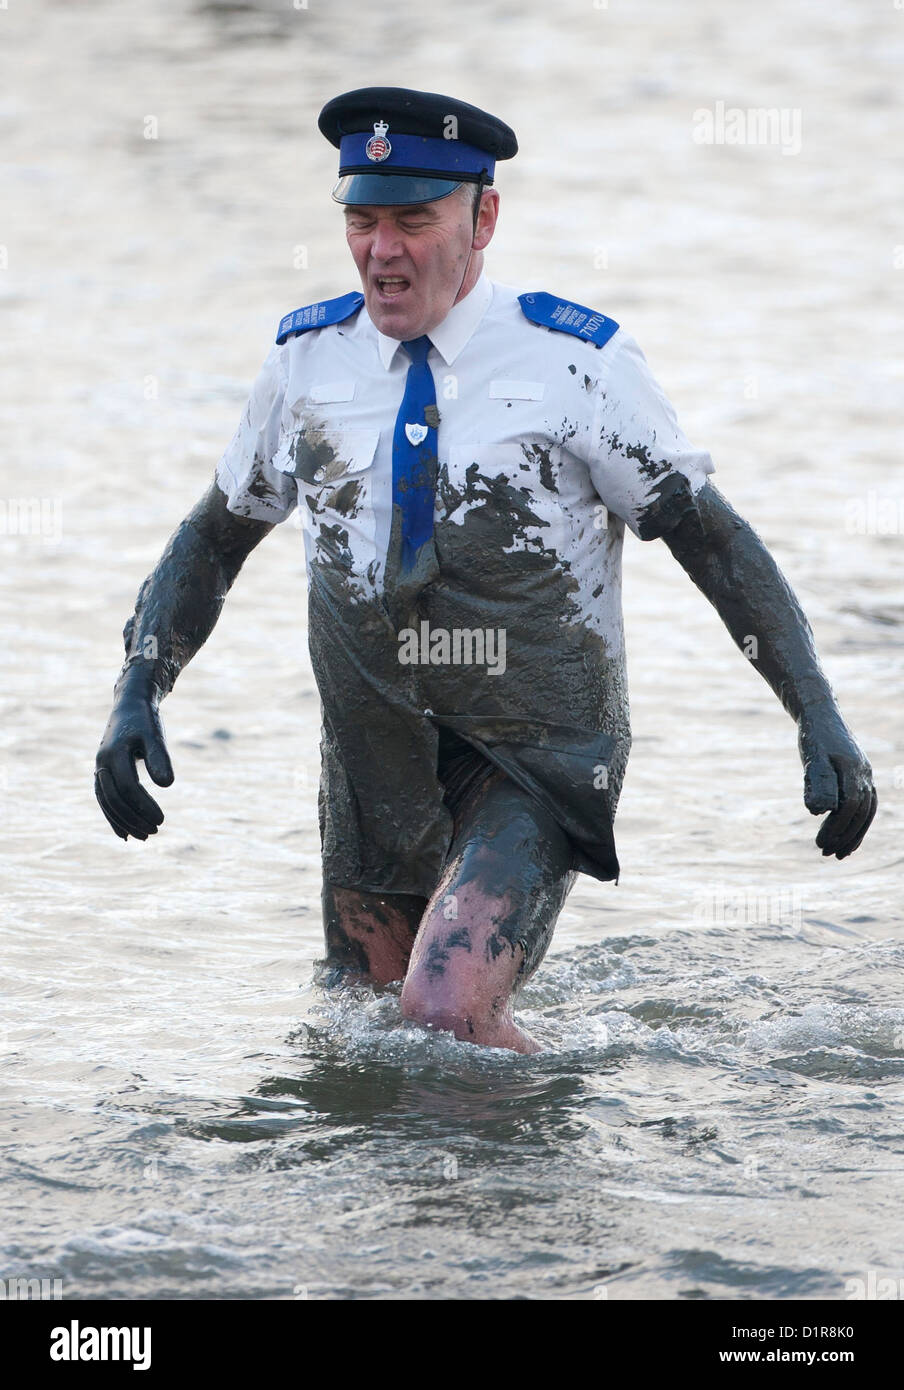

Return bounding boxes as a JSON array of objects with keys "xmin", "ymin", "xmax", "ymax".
[{"xmin": 96, "ymin": 88, "xmax": 876, "ymax": 1052}]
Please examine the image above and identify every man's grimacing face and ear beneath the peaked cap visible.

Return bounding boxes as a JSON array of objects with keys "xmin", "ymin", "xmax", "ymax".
[{"xmin": 345, "ymin": 186, "xmax": 499, "ymax": 342}]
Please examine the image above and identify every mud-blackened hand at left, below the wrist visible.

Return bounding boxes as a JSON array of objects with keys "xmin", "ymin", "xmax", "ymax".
[{"xmin": 95, "ymin": 691, "xmax": 172, "ymax": 840}]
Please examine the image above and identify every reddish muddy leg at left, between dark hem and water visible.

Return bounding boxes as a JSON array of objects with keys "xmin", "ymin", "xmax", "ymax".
[{"xmin": 317, "ymin": 883, "xmax": 427, "ymax": 987}]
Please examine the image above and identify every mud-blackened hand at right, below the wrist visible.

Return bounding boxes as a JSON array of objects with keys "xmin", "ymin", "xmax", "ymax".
[{"xmin": 797, "ymin": 705, "xmax": 879, "ymax": 859}]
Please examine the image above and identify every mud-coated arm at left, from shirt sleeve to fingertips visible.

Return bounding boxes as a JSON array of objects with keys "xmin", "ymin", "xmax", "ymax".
[{"xmin": 95, "ymin": 482, "xmax": 273, "ymax": 840}]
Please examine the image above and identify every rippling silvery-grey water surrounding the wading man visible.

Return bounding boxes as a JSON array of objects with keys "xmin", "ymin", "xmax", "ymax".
[{"xmin": 0, "ymin": 0, "xmax": 904, "ymax": 1300}]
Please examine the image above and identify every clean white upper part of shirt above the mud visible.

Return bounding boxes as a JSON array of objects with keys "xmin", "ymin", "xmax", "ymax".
[{"xmin": 217, "ymin": 272, "xmax": 713, "ymax": 655}]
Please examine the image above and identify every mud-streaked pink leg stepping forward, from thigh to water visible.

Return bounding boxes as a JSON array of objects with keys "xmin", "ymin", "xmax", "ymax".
[{"xmin": 402, "ymin": 771, "xmax": 576, "ymax": 1052}]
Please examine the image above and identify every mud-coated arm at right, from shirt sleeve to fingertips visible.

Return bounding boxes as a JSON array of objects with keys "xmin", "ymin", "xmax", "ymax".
[{"xmin": 653, "ymin": 481, "xmax": 878, "ymax": 859}]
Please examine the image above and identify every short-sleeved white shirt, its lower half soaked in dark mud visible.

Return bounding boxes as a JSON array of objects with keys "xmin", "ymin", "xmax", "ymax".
[{"xmin": 217, "ymin": 275, "xmax": 713, "ymax": 897}]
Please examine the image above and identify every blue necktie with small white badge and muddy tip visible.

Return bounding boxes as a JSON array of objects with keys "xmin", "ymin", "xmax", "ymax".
[{"xmin": 385, "ymin": 335, "xmax": 438, "ymax": 612}]
